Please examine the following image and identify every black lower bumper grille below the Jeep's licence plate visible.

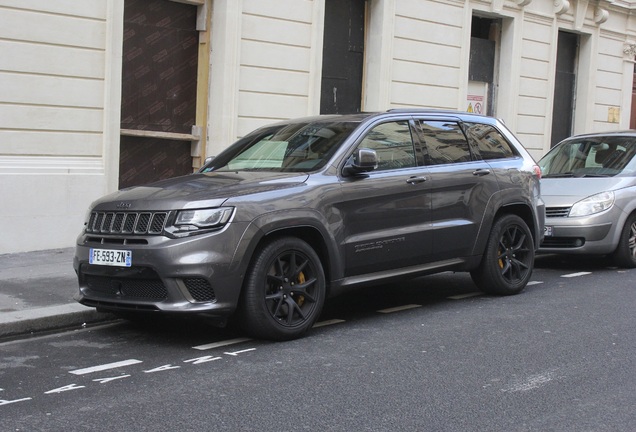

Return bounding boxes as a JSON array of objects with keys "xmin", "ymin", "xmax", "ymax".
[{"xmin": 84, "ymin": 275, "xmax": 168, "ymax": 301}]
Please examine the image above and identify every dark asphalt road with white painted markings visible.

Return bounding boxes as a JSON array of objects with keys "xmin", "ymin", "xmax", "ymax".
[{"xmin": 0, "ymin": 257, "xmax": 636, "ymax": 432}]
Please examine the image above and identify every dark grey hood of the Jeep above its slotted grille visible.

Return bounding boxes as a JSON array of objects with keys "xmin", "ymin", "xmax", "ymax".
[{"xmin": 93, "ymin": 171, "xmax": 308, "ymax": 211}]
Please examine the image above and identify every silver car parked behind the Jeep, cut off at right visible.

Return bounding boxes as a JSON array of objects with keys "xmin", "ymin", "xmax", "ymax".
[{"xmin": 539, "ymin": 130, "xmax": 636, "ymax": 268}]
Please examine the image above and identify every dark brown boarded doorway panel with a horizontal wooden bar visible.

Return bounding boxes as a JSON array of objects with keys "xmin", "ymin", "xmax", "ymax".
[{"xmin": 119, "ymin": 0, "xmax": 199, "ymax": 188}]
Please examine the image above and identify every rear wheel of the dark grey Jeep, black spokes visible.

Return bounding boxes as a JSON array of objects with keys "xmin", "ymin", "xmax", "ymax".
[{"xmin": 470, "ymin": 214, "xmax": 534, "ymax": 295}]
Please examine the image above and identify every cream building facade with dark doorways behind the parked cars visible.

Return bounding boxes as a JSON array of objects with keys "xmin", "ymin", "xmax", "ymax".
[{"xmin": 0, "ymin": 0, "xmax": 636, "ymax": 254}]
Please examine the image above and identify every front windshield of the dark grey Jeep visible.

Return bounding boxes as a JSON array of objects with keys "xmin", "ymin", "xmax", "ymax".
[{"xmin": 201, "ymin": 122, "xmax": 358, "ymax": 172}]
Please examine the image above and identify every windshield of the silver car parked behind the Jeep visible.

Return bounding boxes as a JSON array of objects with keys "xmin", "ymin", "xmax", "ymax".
[{"xmin": 539, "ymin": 136, "xmax": 636, "ymax": 178}]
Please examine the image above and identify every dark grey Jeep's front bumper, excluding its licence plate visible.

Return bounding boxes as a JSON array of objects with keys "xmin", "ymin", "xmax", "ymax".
[{"xmin": 73, "ymin": 224, "xmax": 251, "ymax": 317}]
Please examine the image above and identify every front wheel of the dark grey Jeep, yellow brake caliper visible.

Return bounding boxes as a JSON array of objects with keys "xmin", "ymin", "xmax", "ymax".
[{"xmin": 239, "ymin": 237, "xmax": 326, "ymax": 341}]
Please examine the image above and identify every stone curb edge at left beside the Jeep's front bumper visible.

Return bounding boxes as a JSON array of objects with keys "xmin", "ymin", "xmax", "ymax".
[{"xmin": 0, "ymin": 304, "xmax": 118, "ymax": 339}]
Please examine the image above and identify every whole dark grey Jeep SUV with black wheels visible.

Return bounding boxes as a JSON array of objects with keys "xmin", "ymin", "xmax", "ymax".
[{"xmin": 74, "ymin": 110, "xmax": 545, "ymax": 340}]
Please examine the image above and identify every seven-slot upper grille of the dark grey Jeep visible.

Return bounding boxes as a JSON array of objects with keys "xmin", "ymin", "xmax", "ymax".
[{"xmin": 86, "ymin": 211, "xmax": 168, "ymax": 235}]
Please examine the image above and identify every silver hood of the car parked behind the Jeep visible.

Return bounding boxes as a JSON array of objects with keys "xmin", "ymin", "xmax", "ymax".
[{"xmin": 541, "ymin": 177, "xmax": 634, "ymax": 207}]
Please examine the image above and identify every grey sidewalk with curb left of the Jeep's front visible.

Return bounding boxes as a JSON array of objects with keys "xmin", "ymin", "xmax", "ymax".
[{"xmin": 0, "ymin": 248, "xmax": 114, "ymax": 339}]
